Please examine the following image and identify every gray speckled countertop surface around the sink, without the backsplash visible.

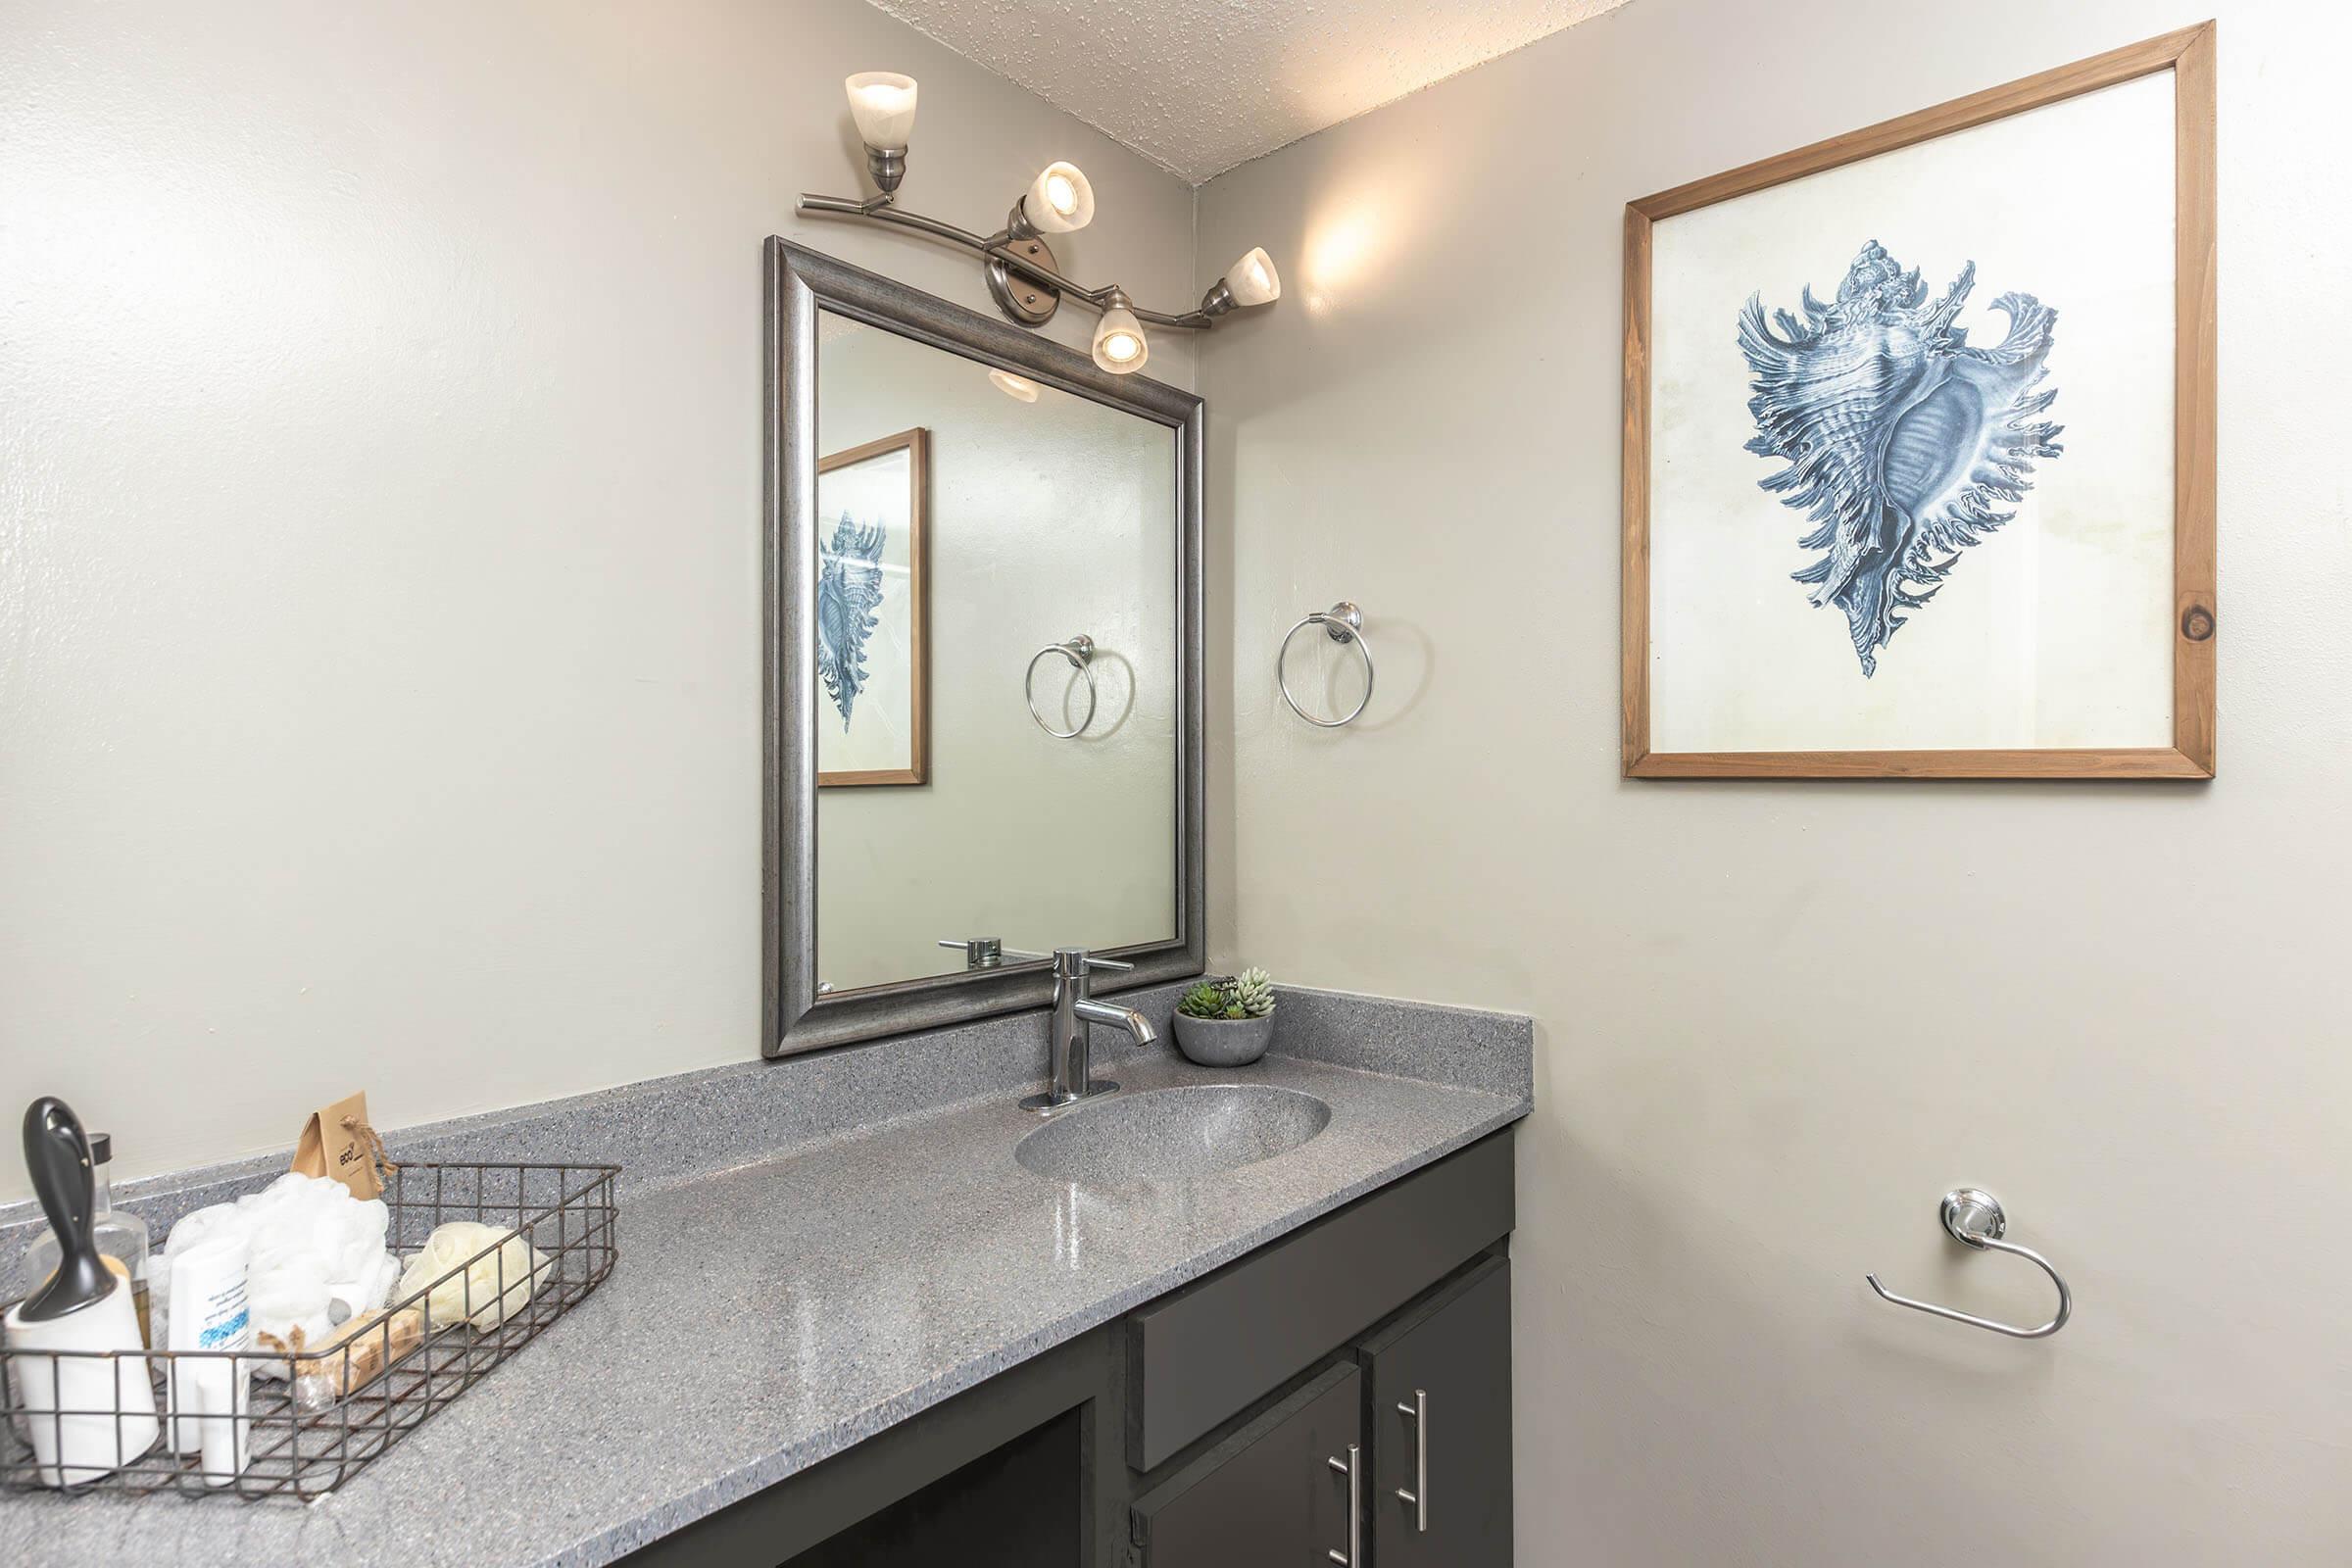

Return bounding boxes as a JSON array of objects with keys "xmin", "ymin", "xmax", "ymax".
[{"xmin": 0, "ymin": 1034, "xmax": 1529, "ymax": 1568}]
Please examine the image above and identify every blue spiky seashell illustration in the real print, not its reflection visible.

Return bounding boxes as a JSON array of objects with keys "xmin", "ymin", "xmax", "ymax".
[{"xmin": 1739, "ymin": 240, "xmax": 2063, "ymax": 677}]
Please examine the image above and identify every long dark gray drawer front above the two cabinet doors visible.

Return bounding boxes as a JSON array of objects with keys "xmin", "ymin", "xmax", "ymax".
[{"xmin": 1127, "ymin": 1128, "xmax": 1512, "ymax": 1472}]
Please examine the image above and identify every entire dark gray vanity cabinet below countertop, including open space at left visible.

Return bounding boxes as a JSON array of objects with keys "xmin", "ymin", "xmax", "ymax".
[{"xmin": 630, "ymin": 1128, "xmax": 1512, "ymax": 1568}]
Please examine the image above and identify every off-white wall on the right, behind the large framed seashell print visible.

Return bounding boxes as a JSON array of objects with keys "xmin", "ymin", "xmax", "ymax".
[{"xmin": 1198, "ymin": 0, "xmax": 2352, "ymax": 1568}]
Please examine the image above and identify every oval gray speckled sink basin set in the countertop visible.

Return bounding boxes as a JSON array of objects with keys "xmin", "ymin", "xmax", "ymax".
[{"xmin": 1013, "ymin": 1084, "xmax": 1331, "ymax": 1185}]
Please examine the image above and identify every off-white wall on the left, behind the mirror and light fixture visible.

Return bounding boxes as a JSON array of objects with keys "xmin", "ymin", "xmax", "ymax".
[{"xmin": 0, "ymin": 0, "xmax": 1195, "ymax": 1199}]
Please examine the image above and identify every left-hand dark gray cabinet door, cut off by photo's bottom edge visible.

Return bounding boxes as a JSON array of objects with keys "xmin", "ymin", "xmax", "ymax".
[{"xmin": 1131, "ymin": 1363, "xmax": 1369, "ymax": 1568}]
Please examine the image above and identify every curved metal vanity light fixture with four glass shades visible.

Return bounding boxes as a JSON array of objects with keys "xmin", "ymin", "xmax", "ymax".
[{"xmin": 800, "ymin": 71, "xmax": 1282, "ymax": 376}]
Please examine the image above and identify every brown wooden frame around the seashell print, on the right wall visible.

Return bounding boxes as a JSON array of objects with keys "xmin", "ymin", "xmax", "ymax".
[{"xmin": 1621, "ymin": 22, "xmax": 2216, "ymax": 778}]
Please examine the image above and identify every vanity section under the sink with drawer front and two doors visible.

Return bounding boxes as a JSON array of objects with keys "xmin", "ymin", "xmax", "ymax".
[{"xmin": 1124, "ymin": 1133, "xmax": 1512, "ymax": 1568}]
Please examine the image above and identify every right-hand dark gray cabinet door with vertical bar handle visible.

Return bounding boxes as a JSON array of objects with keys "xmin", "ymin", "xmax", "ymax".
[{"xmin": 1357, "ymin": 1257, "xmax": 1510, "ymax": 1568}]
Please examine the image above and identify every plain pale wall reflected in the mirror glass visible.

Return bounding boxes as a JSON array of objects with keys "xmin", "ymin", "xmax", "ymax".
[{"xmin": 816, "ymin": 318, "xmax": 1178, "ymax": 990}]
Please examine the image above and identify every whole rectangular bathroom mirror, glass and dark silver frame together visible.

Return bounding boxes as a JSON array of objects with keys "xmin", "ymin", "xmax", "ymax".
[{"xmin": 762, "ymin": 240, "xmax": 1204, "ymax": 1055}]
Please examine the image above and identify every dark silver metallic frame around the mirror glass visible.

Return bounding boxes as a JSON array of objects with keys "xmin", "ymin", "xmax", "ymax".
[{"xmin": 760, "ymin": 235, "xmax": 1209, "ymax": 1055}]
